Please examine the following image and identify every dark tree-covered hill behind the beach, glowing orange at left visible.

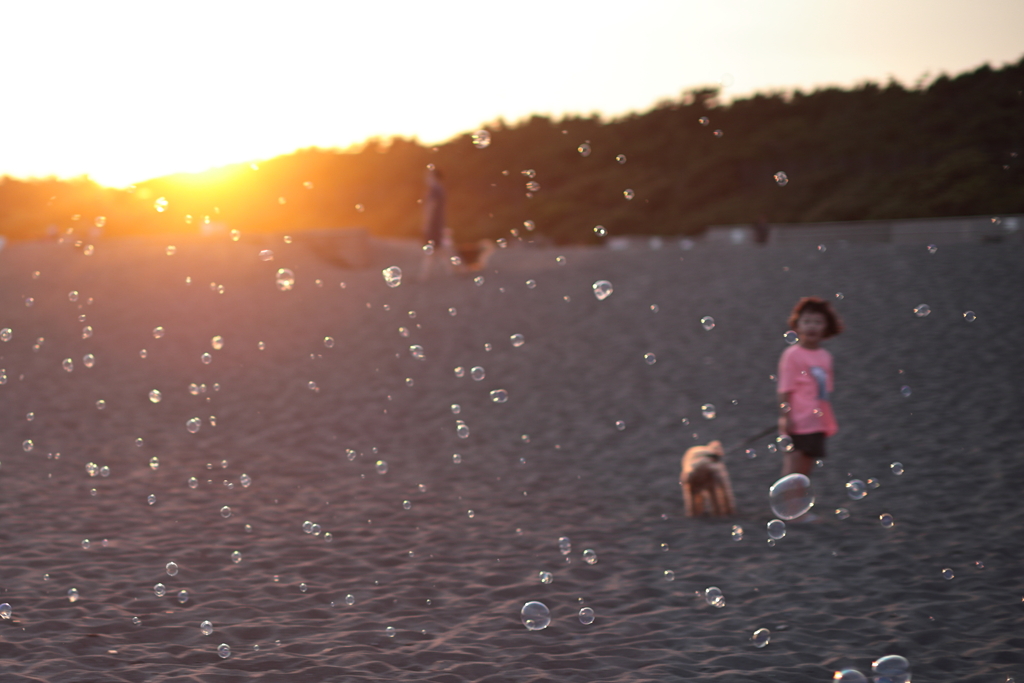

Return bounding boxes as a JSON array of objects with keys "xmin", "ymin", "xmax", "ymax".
[{"xmin": 0, "ymin": 59, "xmax": 1024, "ymax": 243}]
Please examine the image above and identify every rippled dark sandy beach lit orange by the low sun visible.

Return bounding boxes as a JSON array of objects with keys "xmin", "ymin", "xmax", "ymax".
[{"xmin": 0, "ymin": 233, "xmax": 1024, "ymax": 683}]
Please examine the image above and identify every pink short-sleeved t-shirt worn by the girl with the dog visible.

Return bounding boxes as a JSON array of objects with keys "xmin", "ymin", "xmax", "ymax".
[{"xmin": 778, "ymin": 344, "xmax": 839, "ymax": 436}]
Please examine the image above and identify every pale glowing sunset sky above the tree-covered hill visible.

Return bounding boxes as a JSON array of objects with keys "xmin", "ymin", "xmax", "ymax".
[{"xmin": 0, "ymin": 0, "xmax": 1024, "ymax": 186}]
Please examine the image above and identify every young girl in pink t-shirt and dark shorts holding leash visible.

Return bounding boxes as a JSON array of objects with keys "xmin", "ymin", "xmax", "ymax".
[{"xmin": 778, "ymin": 297, "xmax": 843, "ymax": 476}]
